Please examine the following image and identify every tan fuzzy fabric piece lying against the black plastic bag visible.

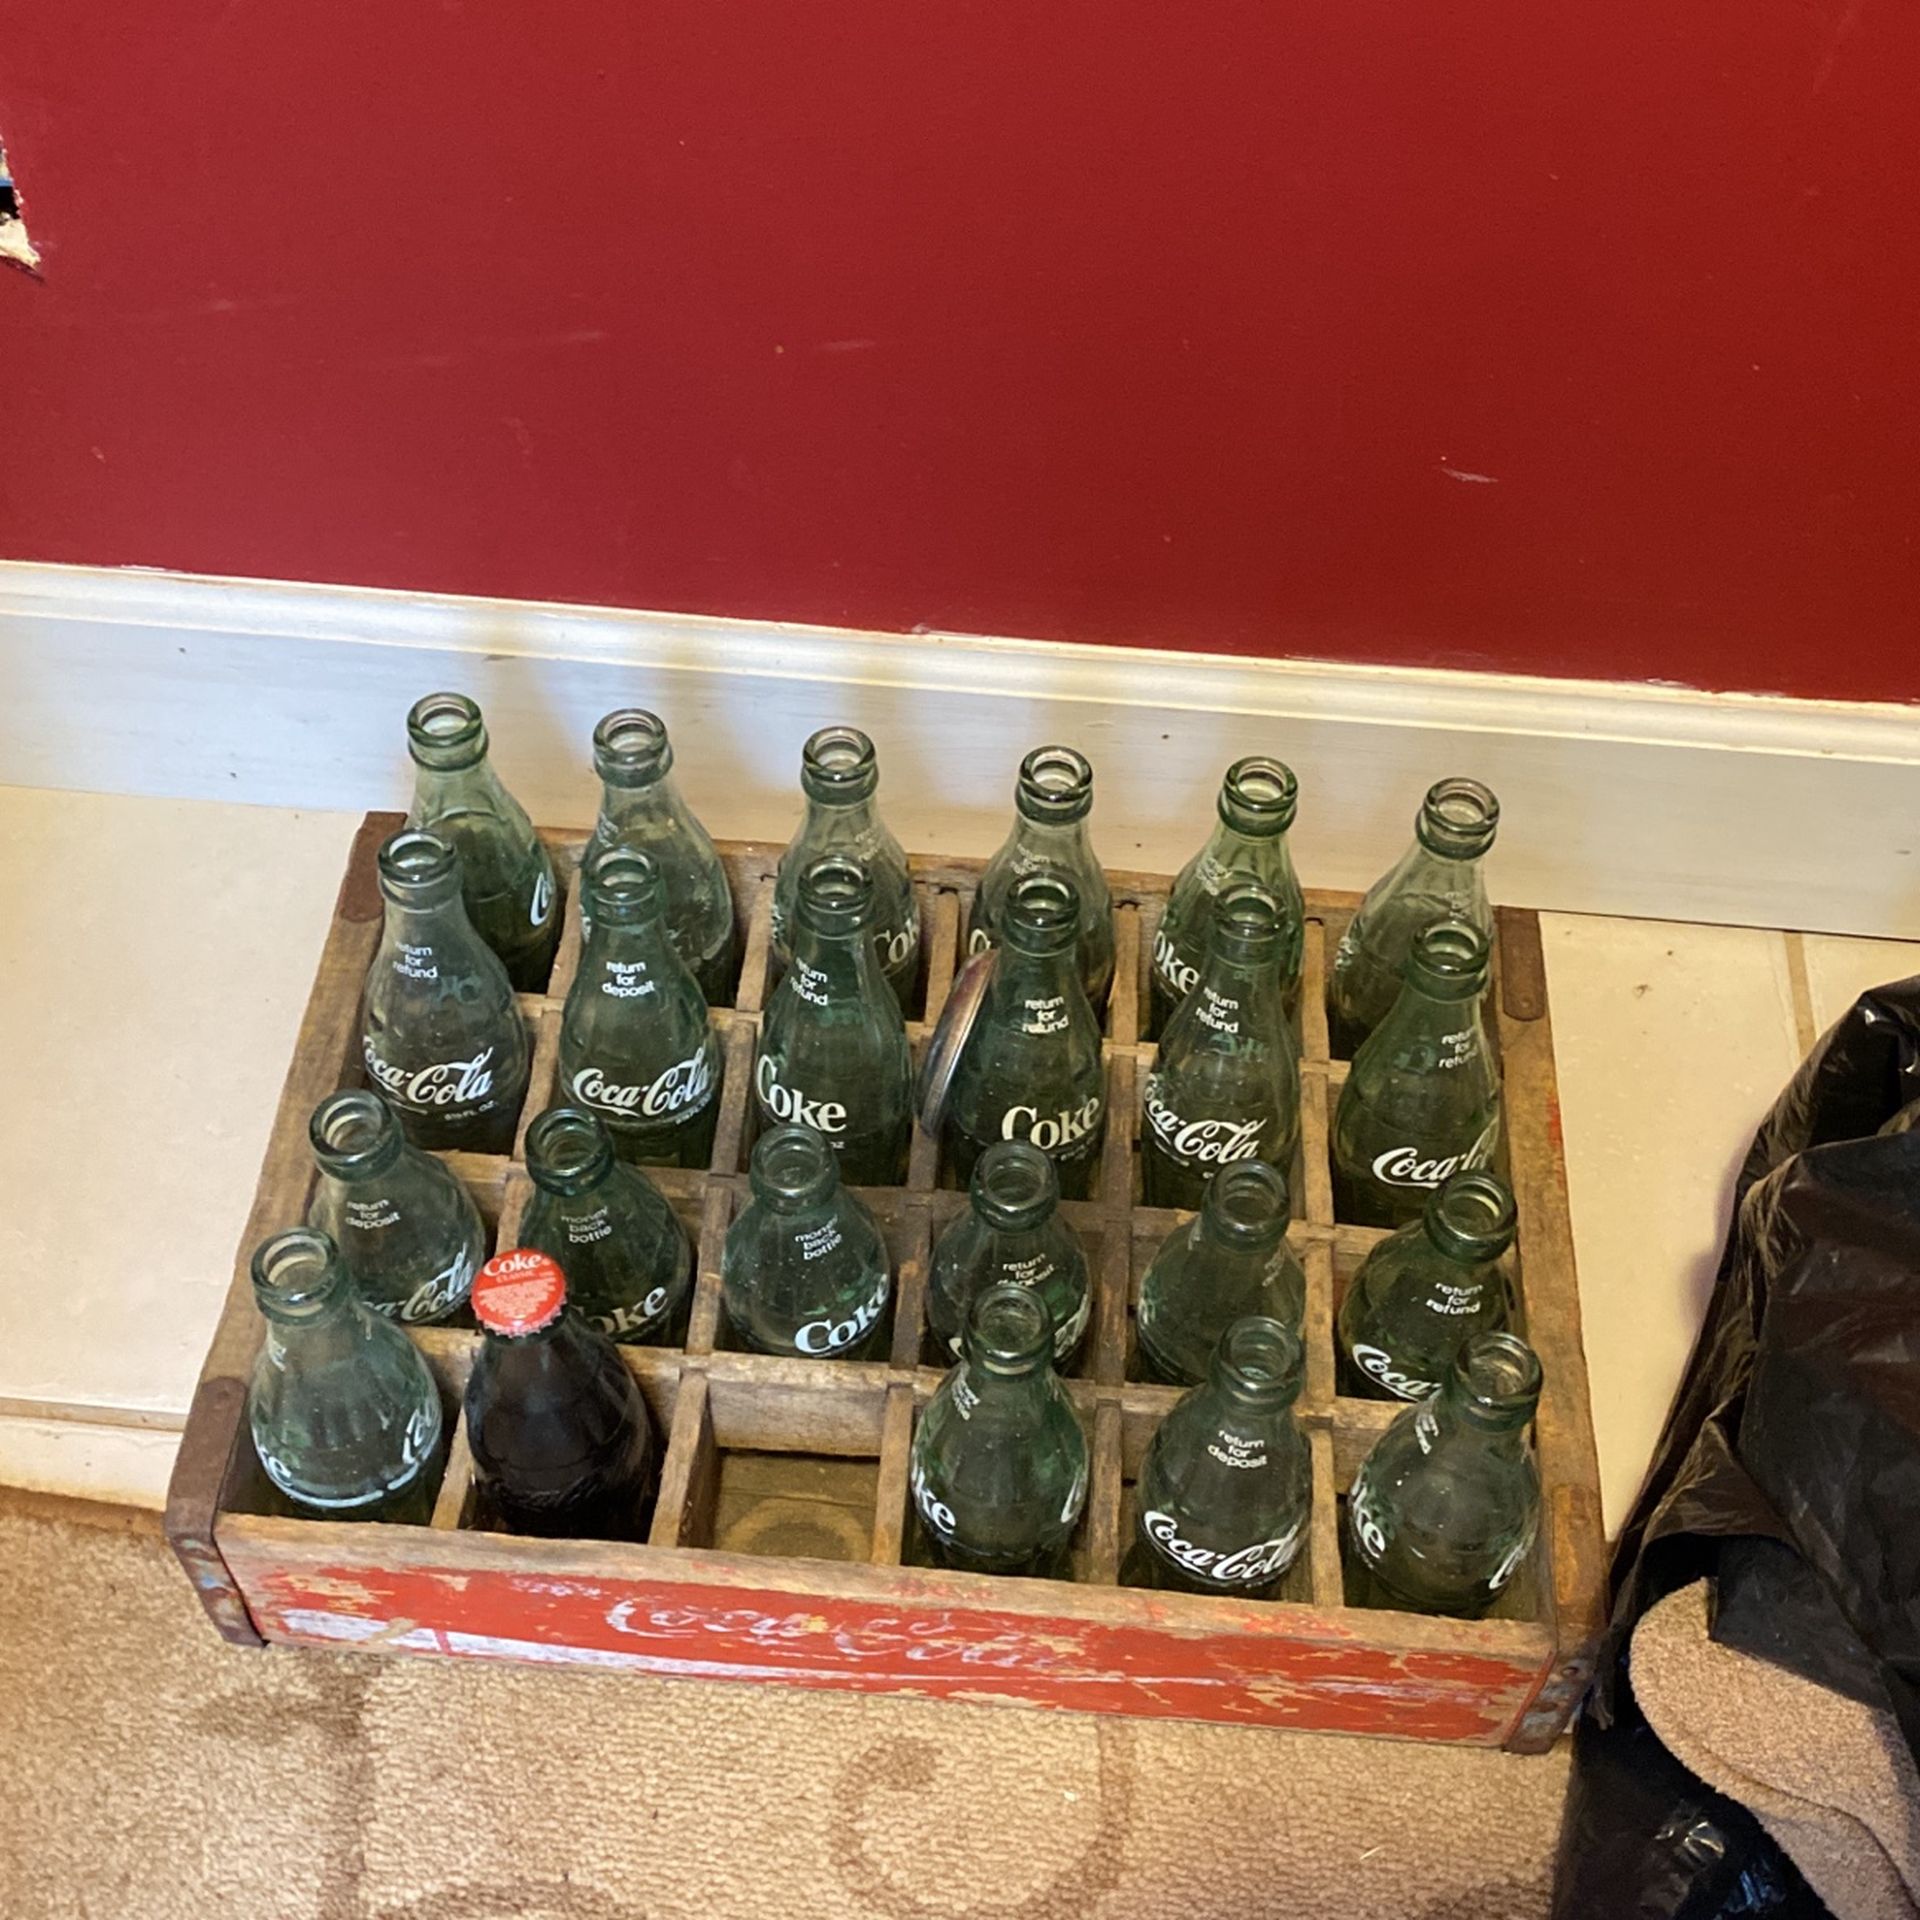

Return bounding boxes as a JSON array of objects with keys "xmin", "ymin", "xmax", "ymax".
[{"xmin": 1632, "ymin": 1580, "xmax": 1920, "ymax": 1920}]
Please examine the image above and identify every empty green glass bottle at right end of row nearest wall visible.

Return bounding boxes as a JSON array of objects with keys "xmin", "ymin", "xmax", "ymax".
[{"xmin": 1327, "ymin": 780, "xmax": 1500, "ymax": 1060}]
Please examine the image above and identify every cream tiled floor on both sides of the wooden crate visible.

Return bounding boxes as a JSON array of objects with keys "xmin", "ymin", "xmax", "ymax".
[{"xmin": 0, "ymin": 787, "xmax": 1920, "ymax": 1526}]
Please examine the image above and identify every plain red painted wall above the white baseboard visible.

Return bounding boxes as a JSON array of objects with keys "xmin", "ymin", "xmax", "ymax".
[{"xmin": 0, "ymin": 0, "xmax": 1920, "ymax": 699}]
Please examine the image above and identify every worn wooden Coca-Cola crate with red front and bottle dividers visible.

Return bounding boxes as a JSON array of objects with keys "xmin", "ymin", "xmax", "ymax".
[{"xmin": 167, "ymin": 814, "xmax": 1603, "ymax": 1751}]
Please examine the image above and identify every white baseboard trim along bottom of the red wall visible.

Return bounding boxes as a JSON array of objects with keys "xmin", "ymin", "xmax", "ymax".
[{"xmin": 0, "ymin": 561, "xmax": 1920, "ymax": 939}]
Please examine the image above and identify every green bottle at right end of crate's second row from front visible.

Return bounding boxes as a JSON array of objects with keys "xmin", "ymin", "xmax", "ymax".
[{"xmin": 1334, "ymin": 1173, "xmax": 1513, "ymax": 1400}]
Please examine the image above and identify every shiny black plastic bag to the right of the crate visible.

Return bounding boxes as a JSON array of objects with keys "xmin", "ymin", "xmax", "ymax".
[{"xmin": 1553, "ymin": 977, "xmax": 1920, "ymax": 1920}]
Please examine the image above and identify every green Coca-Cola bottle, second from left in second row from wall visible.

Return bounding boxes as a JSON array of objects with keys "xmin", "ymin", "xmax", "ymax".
[{"xmin": 559, "ymin": 847, "xmax": 720, "ymax": 1167}]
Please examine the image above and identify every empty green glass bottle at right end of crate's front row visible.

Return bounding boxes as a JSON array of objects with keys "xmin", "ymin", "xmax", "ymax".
[{"xmin": 1346, "ymin": 1332, "xmax": 1540, "ymax": 1617}]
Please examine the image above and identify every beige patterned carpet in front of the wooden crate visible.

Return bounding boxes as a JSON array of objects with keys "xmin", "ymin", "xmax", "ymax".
[{"xmin": 0, "ymin": 1494, "xmax": 1567, "ymax": 1920}]
